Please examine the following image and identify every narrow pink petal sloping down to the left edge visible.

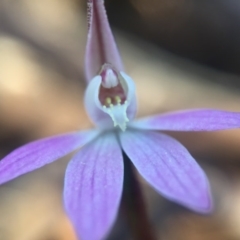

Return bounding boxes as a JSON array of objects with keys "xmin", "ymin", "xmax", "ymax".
[{"xmin": 0, "ymin": 131, "xmax": 98, "ymax": 184}]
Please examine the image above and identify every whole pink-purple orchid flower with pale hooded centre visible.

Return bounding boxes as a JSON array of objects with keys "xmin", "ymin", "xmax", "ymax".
[{"xmin": 0, "ymin": 0, "xmax": 240, "ymax": 240}]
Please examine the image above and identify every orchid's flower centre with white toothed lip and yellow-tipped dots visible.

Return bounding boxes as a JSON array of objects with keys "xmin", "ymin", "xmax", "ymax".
[{"xmin": 99, "ymin": 65, "xmax": 129, "ymax": 131}]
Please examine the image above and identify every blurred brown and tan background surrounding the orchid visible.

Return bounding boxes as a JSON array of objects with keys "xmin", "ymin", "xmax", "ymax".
[{"xmin": 0, "ymin": 0, "xmax": 240, "ymax": 240}]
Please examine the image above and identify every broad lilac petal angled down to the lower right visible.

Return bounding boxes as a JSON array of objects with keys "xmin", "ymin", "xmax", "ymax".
[{"xmin": 120, "ymin": 131, "xmax": 212, "ymax": 213}]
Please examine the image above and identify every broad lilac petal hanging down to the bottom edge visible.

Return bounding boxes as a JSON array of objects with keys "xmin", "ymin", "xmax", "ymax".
[{"xmin": 64, "ymin": 132, "xmax": 123, "ymax": 240}]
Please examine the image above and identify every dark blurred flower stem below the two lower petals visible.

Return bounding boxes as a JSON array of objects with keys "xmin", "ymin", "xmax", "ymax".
[{"xmin": 122, "ymin": 153, "xmax": 156, "ymax": 240}]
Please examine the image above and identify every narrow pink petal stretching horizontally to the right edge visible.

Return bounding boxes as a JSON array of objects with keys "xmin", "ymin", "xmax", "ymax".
[{"xmin": 131, "ymin": 109, "xmax": 240, "ymax": 131}]
